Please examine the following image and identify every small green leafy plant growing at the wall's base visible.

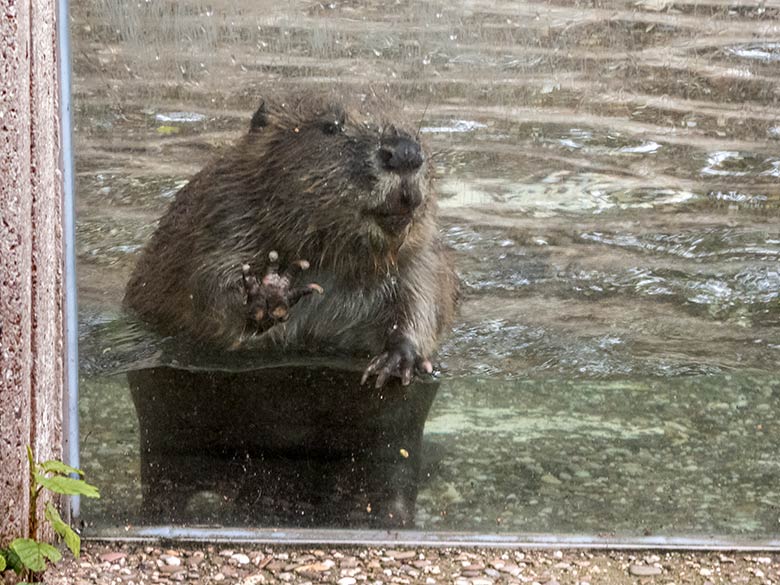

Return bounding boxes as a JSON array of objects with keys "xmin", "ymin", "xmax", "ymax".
[{"xmin": 0, "ymin": 447, "xmax": 100, "ymax": 582}]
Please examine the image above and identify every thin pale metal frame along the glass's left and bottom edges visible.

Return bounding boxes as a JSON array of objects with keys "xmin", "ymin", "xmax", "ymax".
[{"xmin": 57, "ymin": 0, "xmax": 780, "ymax": 551}]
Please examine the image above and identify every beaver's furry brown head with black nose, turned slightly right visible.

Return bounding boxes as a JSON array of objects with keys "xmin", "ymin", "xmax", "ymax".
[{"xmin": 246, "ymin": 97, "xmax": 436, "ymax": 262}]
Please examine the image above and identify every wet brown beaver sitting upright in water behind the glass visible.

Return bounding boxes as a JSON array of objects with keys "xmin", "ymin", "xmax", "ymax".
[{"xmin": 124, "ymin": 96, "xmax": 457, "ymax": 387}]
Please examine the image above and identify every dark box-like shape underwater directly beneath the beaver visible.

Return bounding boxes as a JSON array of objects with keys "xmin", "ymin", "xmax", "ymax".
[{"xmin": 128, "ymin": 360, "xmax": 438, "ymax": 528}]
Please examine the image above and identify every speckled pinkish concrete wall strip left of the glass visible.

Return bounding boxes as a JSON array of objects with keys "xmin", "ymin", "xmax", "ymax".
[{"xmin": 0, "ymin": 0, "xmax": 63, "ymax": 542}]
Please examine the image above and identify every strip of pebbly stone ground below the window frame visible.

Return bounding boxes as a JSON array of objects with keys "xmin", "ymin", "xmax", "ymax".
[{"xmin": 10, "ymin": 542, "xmax": 780, "ymax": 585}]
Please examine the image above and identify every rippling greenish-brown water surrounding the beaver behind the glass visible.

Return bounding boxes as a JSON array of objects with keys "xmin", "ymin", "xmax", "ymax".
[{"xmin": 72, "ymin": 0, "xmax": 780, "ymax": 538}]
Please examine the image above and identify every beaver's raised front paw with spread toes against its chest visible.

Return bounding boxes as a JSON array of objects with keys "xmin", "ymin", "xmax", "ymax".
[{"xmin": 241, "ymin": 252, "xmax": 323, "ymax": 331}]
